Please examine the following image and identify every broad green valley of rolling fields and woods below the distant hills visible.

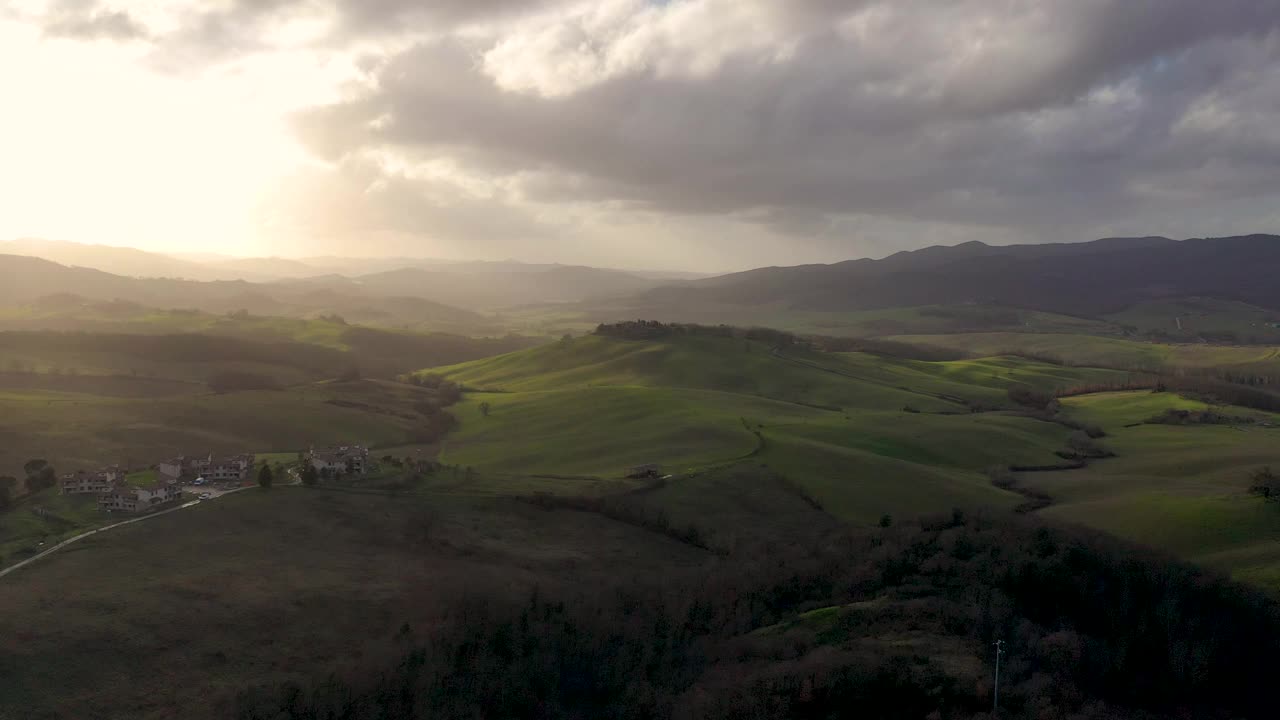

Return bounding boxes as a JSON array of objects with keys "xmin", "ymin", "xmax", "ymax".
[{"xmin": 0, "ymin": 233, "xmax": 1280, "ymax": 720}]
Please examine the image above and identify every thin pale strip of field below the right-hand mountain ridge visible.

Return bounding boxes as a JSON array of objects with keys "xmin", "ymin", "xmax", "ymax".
[{"xmin": 892, "ymin": 333, "xmax": 1280, "ymax": 370}]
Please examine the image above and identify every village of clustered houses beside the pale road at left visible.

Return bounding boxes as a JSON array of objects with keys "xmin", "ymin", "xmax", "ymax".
[{"xmin": 59, "ymin": 445, "xmax": 371, "ymax": 514}]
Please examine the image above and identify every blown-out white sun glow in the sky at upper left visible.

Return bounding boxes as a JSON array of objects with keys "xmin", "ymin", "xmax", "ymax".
[{"xmin": 0, "ymin": 23, "xmax": 326, "ymax": 252}]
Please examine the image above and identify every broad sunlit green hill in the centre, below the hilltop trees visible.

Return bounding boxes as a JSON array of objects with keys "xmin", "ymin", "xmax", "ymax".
[{"xmin": 433, "ymin": 336, "xmax": 1125, "ymax": 521}]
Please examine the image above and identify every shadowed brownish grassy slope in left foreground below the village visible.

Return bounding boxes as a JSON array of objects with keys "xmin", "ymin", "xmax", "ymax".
[{"xmin": 0, "ymin": 488, "xmax": 713, "ymax": 720}]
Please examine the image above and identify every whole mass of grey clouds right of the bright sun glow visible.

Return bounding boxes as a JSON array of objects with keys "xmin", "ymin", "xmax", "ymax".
[{"xmin": 20, "ymin": 0, "xmax": 1280, "ymax": 263}]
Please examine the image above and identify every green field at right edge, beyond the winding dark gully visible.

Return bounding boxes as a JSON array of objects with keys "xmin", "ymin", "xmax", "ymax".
[{"xmin": 1023, "ymin": 392, "xmax": 1280, "ymax": 592}]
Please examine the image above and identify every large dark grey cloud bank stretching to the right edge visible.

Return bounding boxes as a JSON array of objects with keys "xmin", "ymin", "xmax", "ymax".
[{"xmin": 288, "ymin": 0, "xmax": 1280, "ymax": 243}]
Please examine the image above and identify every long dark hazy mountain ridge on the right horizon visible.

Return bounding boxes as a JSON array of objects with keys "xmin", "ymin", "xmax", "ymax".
[{"xmin": 636, "ymin": 234, "xmax": 1280, "ymax": 315}]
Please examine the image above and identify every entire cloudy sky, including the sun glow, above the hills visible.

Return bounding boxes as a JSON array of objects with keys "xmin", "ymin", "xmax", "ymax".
[{"xmin": 0, "ymin": 0, "xmax": 1280, "ymax": 270}]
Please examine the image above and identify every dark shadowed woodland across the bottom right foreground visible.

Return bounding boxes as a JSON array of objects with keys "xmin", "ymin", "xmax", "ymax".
[{"xmin": 234, "ymin": 511, "xmax": 1280, "ymax": 720}]
